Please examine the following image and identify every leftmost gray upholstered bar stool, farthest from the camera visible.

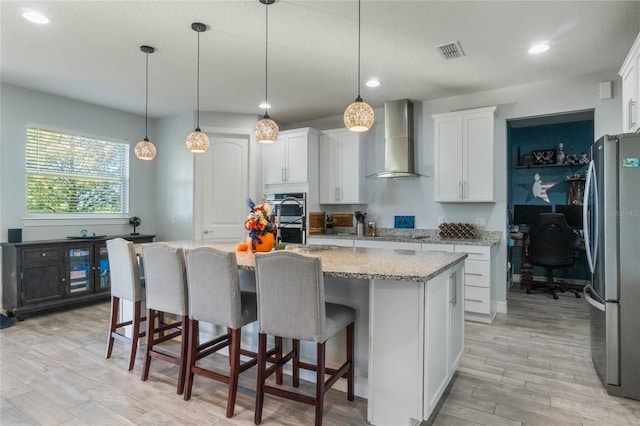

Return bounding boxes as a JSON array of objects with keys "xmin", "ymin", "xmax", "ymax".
[{"xmin": 105, "ymin": 238, "xmax": 146, "ymax": 370}]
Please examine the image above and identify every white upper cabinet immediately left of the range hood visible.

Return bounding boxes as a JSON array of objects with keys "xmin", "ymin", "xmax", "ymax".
[{"xmin": 319, "ymin": 129, "xmax": 365, "ymax": 204}]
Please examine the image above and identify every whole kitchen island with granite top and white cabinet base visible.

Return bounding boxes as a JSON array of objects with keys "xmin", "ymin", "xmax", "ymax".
[{"xmin": 145, "ymin": 241, "xmax": 467, "ymax": 425}]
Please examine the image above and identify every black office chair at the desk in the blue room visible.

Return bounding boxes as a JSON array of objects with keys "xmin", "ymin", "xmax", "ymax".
[{"xmin": 527, "ymin": 213, "xmax": 580, "ymax": 299}]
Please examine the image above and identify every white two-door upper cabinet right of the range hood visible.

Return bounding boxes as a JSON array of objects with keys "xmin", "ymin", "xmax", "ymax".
[{"xmin": 431, "ymin": 106, "xmax": 496, "ymax": 203}]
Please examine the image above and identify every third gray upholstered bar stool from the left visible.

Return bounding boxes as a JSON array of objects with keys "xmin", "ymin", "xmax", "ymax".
[{"xmin": 184, "ymin": 247, "xmax": 257, "ymax": 417}]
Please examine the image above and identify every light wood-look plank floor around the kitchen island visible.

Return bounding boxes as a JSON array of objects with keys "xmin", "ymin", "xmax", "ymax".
[{"xmin": 0, "ymin": 289, "xmax": 640, "ymax": 426}]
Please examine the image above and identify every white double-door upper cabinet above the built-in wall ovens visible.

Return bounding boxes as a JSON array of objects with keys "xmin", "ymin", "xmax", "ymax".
[{"xmin": 262, "ymin": 128, "xmax": 318, "ymax": 185}]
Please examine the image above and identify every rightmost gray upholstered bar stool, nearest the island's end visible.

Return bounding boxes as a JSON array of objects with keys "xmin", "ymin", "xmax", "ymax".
[{"xmin": 254, "ymin": 251, "xmax": 356, "ymax": 425}]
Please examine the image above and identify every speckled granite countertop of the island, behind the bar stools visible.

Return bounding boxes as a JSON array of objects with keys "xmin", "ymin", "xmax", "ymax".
[{"xmin": 148, "ymin": 240, "xmax": 467, "ymax": 282}]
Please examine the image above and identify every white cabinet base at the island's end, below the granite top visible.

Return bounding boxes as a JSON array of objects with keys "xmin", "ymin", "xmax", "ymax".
[{"xmin": 368, "ymin": 262, "xmax": 464, "ymax": 425}]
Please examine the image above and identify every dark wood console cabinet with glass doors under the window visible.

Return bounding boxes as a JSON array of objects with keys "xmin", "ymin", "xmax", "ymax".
[{"xmin": 2, "ymin": 235, "xmax": 155, "ymax": 319}]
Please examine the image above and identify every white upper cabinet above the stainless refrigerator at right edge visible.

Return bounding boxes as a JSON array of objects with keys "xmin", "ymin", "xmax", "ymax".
[{"xmin": 618, "ymin": 33, "xmax": 640, "ymax": 132}]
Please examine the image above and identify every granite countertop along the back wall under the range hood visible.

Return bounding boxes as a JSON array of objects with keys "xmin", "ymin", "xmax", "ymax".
[{"xmin": 309, "ymin": 228, "xmax": 502, "ymax": 246}]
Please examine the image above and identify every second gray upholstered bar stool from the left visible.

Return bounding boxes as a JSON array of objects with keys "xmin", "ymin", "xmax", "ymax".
[{"xmin": 142, "ymin": 243, "xmax": 189, "ymax": 394}]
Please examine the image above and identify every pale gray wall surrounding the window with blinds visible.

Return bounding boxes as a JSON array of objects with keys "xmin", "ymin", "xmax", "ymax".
[{"xmin": 0, "ymin": 84, "xmax": 156, "ymax": 241}]
